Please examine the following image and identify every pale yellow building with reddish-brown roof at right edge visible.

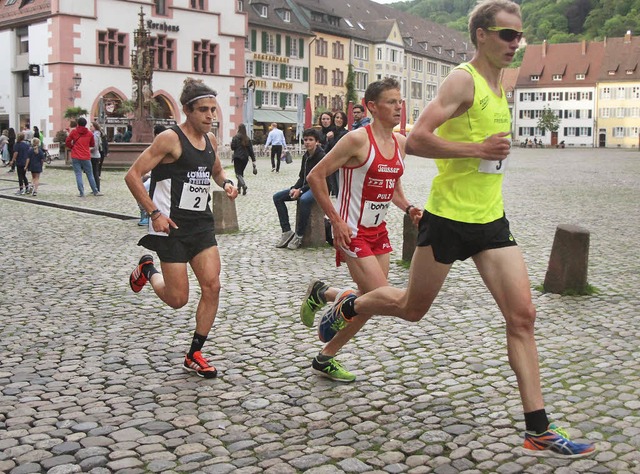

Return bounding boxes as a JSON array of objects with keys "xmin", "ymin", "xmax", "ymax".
[{"xmin": 597, "ymin": 32, "xmax": 640, "ymax": 148}]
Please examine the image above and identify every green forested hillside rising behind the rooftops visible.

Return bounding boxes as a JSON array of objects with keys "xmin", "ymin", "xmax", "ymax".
[{"xmin": 391, "ymin": 0, "xmax": 640, "ymax": 43}]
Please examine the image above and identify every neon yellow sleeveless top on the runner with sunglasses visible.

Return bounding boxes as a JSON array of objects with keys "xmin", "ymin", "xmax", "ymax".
[{"xmin": 426, "ymin": 63, "xmax": 511, "ymax": 224}]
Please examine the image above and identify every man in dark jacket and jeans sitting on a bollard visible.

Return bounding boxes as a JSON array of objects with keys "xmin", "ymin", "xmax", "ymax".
[{"xmin": 273, "ymin": 128, "xmax": 324, "ymax": 250}]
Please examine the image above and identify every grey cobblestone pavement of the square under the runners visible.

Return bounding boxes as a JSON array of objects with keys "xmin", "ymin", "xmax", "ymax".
[{"xmin": 0, "ymin": 149, "xmax": 640, "ymax": 474}]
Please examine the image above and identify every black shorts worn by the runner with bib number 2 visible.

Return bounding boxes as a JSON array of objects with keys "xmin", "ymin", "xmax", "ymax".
[{"xmin": 138, "ymin": 231, "xmax": 218, "ymax": 263}]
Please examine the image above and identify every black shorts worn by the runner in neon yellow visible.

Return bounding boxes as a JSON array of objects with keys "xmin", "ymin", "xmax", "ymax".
[{"xmin": 417, "ymin": 211, "xmax": 518, "ymax": 264}]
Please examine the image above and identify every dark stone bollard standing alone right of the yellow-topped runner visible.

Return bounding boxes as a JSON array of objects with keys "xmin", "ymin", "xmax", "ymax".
[{"xmin": 544, "ymin": 224, "xmax": 590, "ymax": 294}]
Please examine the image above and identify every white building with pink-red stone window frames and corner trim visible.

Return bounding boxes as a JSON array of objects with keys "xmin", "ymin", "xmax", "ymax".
[{"xmin": 0, "ymin": 0, "xmax": 247, "ymax": 143}]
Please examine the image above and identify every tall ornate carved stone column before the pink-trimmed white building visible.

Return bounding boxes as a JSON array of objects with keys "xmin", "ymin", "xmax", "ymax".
[{"xmin": 131, "ymin": 7, "xmax": 153, "ymax": 143}]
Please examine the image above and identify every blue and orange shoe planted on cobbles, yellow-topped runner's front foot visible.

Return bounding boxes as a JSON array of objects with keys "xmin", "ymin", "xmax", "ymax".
[{"xmin": 522, "ymin": 423, "xmax": 596, "ymax": 459}]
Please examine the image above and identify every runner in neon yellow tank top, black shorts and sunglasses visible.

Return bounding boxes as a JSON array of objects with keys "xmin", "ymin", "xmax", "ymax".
[{"xmin": 320, "ymin": 0, "xmax": 595, "ymax": 458}]
